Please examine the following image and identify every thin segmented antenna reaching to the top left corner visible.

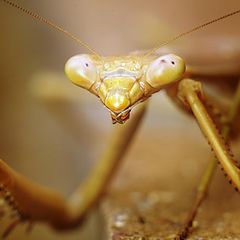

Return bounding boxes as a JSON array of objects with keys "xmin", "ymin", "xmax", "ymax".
[{"xmin": 0, "ymin": 0, "xmax": 102, "ymax": 59}]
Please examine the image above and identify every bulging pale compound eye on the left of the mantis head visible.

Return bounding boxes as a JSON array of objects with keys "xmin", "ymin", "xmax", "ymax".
[{"xmin": 65, "ymin": 54, "xmax": 99, "ymax": 90}]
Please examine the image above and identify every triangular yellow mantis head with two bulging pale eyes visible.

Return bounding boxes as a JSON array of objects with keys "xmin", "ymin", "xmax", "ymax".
[{"xmin": 65, "ymin": 54, "xmax": 185, "ymax": 123}]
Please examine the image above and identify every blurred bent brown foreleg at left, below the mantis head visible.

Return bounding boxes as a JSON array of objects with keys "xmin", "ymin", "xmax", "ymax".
[{"xmin": 0, "ymin": 103, "xmax": 146, "ymax": 233}]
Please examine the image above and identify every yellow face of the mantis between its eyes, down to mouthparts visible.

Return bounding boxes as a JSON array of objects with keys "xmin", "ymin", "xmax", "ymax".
[{"xmin": 96, "ymin": 56, "xmax": 144, "ymax": 123}]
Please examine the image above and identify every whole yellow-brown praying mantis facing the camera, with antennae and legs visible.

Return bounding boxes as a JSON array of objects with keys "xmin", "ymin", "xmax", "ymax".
[{"xmin": 0, "ymin": 0, "xmax": 240, "ymax": 239}]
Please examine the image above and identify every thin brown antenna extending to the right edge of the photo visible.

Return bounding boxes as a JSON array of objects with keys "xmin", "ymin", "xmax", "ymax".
[{"xmin": 143, "ymin": 9, "xmax": 240, "ymax": 58}]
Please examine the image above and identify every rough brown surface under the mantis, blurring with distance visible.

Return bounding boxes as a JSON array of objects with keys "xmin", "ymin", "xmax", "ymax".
[{"xmin": 101, "ymin": 103, "xmax": 240, "ymax": 240}]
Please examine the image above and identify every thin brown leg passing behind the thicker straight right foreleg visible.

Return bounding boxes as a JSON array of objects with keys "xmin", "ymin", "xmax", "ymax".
[{"xmin": 175, "ymin": 78, "xmax": 240, "ymax": 240}]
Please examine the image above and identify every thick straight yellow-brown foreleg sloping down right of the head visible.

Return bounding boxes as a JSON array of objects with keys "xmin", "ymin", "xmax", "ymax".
[{"xmin": 176, "ymin": 79, "xmax": 240, "ymax": 190}]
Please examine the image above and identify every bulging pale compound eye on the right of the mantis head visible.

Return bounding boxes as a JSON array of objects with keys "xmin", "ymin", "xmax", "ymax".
[{"xmin": 146, "ymin": 54, "xmax": 185, "ymax": 89}]
